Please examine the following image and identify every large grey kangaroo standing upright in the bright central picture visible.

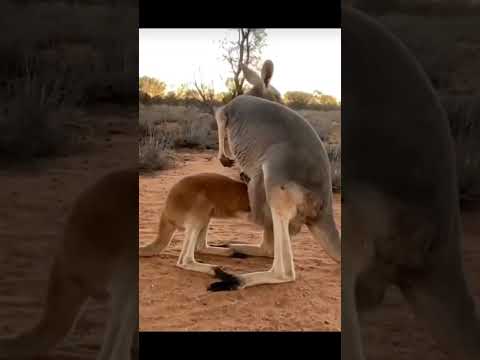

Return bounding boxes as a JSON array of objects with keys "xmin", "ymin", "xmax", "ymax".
[{"xmin": 210, "ymin": 61, "xmax": 341, "ymax": 290}]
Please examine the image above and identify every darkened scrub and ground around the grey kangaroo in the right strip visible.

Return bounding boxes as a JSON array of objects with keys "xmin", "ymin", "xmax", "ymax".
[{"xmin": 343, "ymin": 0, "xmax": 480, "ymax": 360}]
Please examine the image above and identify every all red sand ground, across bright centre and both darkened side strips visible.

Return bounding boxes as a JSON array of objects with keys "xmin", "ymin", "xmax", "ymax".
[{"xmin": 0, "ymin": 129, "xmax": 480, "ymax": 360}]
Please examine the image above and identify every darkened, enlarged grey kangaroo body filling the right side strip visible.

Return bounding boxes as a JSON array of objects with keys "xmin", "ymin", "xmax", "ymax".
[{"xmin": 342, "ymin": 7, "xmax": 480, "ymax": 360}]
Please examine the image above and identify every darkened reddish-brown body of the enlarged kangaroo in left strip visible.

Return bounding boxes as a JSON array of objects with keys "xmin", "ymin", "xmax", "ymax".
[{"xmin": 0, "ymin": 169, "xmax": 138, "ymax": 359}]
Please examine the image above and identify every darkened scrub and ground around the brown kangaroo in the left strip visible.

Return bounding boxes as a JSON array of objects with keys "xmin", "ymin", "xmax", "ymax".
[{"xmin": 0, "ymin": 0, "xmax": 138, "ymax": 360}]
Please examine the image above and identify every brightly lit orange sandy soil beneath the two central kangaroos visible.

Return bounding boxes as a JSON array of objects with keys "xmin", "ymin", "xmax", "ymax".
[{"xmin": 139, "ymin": 151, "xmax": 341, "ymax": 331}]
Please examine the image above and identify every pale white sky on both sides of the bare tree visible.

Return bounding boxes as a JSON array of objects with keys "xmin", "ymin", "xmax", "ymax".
[{"xmin": 139, "ymin": 29, "xmax": 342, "ymax": 100}]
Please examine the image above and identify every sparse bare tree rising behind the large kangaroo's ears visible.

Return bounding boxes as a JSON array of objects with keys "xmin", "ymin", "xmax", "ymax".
[{"xmin": 221, "ymin": 28, "xmax": 267, "ymax": 97}]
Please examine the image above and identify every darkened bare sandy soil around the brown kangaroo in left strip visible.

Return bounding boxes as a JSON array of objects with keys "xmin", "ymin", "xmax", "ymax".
[{"xmin": 0, "ymin": 110, "xmax": 138, "ymax": 360}]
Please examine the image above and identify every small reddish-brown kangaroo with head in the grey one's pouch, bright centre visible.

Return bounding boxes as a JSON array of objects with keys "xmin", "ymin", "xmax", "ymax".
[{"xmin": 139, "ymin": 173, "xmax": 292, "ymax": 275}]
